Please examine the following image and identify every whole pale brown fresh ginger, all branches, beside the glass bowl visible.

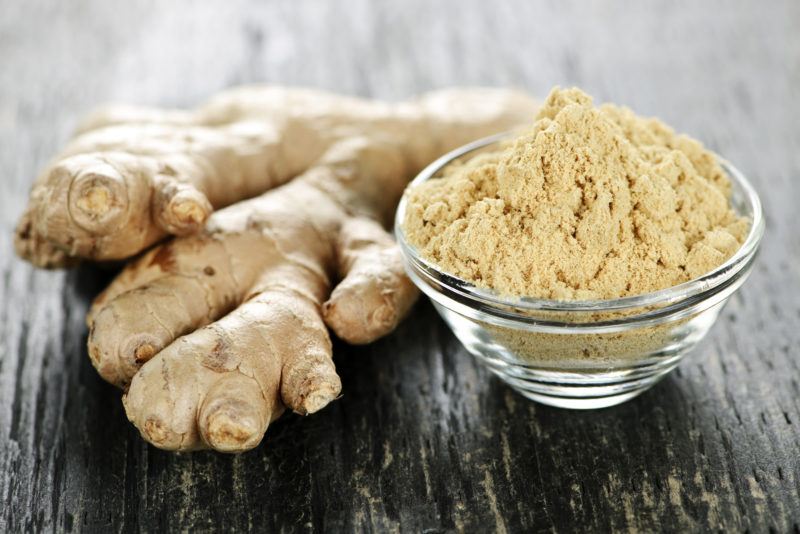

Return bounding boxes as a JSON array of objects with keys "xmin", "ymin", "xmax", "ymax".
[{"xmin": 32, "ymin": 87, "xmax": 535, "ymax": 452}]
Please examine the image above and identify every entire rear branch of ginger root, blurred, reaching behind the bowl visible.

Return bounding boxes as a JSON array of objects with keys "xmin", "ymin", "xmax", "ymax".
[{"xmin": 15, "ymin": 86, "xmax": 532, "ymax": 268}]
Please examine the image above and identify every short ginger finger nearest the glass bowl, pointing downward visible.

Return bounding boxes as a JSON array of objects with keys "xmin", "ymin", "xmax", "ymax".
[{"xmin": 323, "ymin": 218, "xmax": 418, "ymax": 344}]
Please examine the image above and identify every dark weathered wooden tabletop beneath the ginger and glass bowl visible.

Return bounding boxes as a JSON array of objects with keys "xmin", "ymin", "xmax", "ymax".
[{"xmin": 0, "ymin": 0, "xmax": 800, "ymax": 533}]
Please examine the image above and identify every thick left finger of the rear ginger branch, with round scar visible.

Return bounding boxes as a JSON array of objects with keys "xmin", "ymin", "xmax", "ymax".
[{"xmin": 15, "ymin": 123, "xmax": 321, "ymax": 267}]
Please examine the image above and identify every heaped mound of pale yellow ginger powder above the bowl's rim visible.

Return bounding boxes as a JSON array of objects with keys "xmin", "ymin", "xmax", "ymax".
[{"xmin": 403, "ymin": 88, "xmax": 749, "ymax": 300}]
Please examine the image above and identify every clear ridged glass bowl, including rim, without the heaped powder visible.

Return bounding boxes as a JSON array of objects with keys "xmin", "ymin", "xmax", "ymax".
[{"xmin": 395, "ymin": 134, "xmax": 764, "ymax": 409}]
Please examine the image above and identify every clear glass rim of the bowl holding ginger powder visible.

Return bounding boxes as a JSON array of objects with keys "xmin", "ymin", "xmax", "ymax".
[{"xmin": 394, "ymin": 131, "xmax": 765, "ymax": 317}]
